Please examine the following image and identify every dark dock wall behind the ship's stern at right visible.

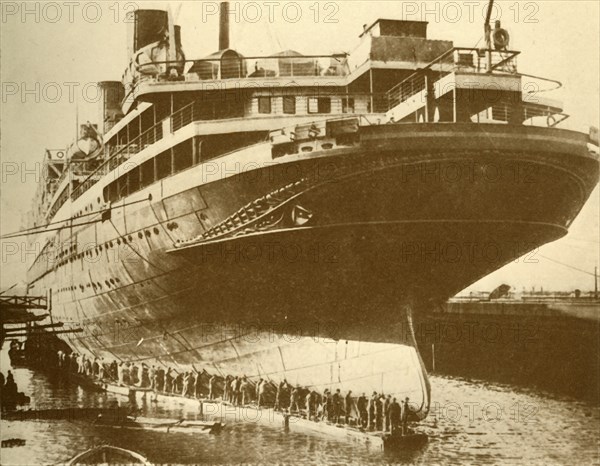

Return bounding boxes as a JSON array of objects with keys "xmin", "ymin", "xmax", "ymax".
[{"xmin": 414, "ymin": 303, "xmax": 600, "ymax": 404}]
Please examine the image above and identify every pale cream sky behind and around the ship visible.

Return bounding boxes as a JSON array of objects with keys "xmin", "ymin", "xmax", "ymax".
[{"xmin": 0, "ymin": 0, "xmax": 600, "ymax": 290}]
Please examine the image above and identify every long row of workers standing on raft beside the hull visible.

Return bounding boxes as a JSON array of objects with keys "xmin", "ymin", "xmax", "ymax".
[{"xmin": 58, "ymin": 351, "xmax": 411, "ymax": 435}]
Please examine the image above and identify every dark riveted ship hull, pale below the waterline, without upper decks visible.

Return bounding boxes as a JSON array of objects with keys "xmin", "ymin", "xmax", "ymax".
[{"xmin": 28, "ymin": 124, "xmax": 598, "ymax": 416}]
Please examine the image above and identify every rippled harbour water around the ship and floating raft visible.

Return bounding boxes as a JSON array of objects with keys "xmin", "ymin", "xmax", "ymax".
[{"xmin": 0, "ymin": 352, "xmax": 600, "ymax": 465}]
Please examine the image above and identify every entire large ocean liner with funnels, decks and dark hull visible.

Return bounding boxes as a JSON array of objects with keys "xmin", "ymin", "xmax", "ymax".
[{"xmin": 21, "ymin": 3, "xmax": 598, "ymax": 418}]
